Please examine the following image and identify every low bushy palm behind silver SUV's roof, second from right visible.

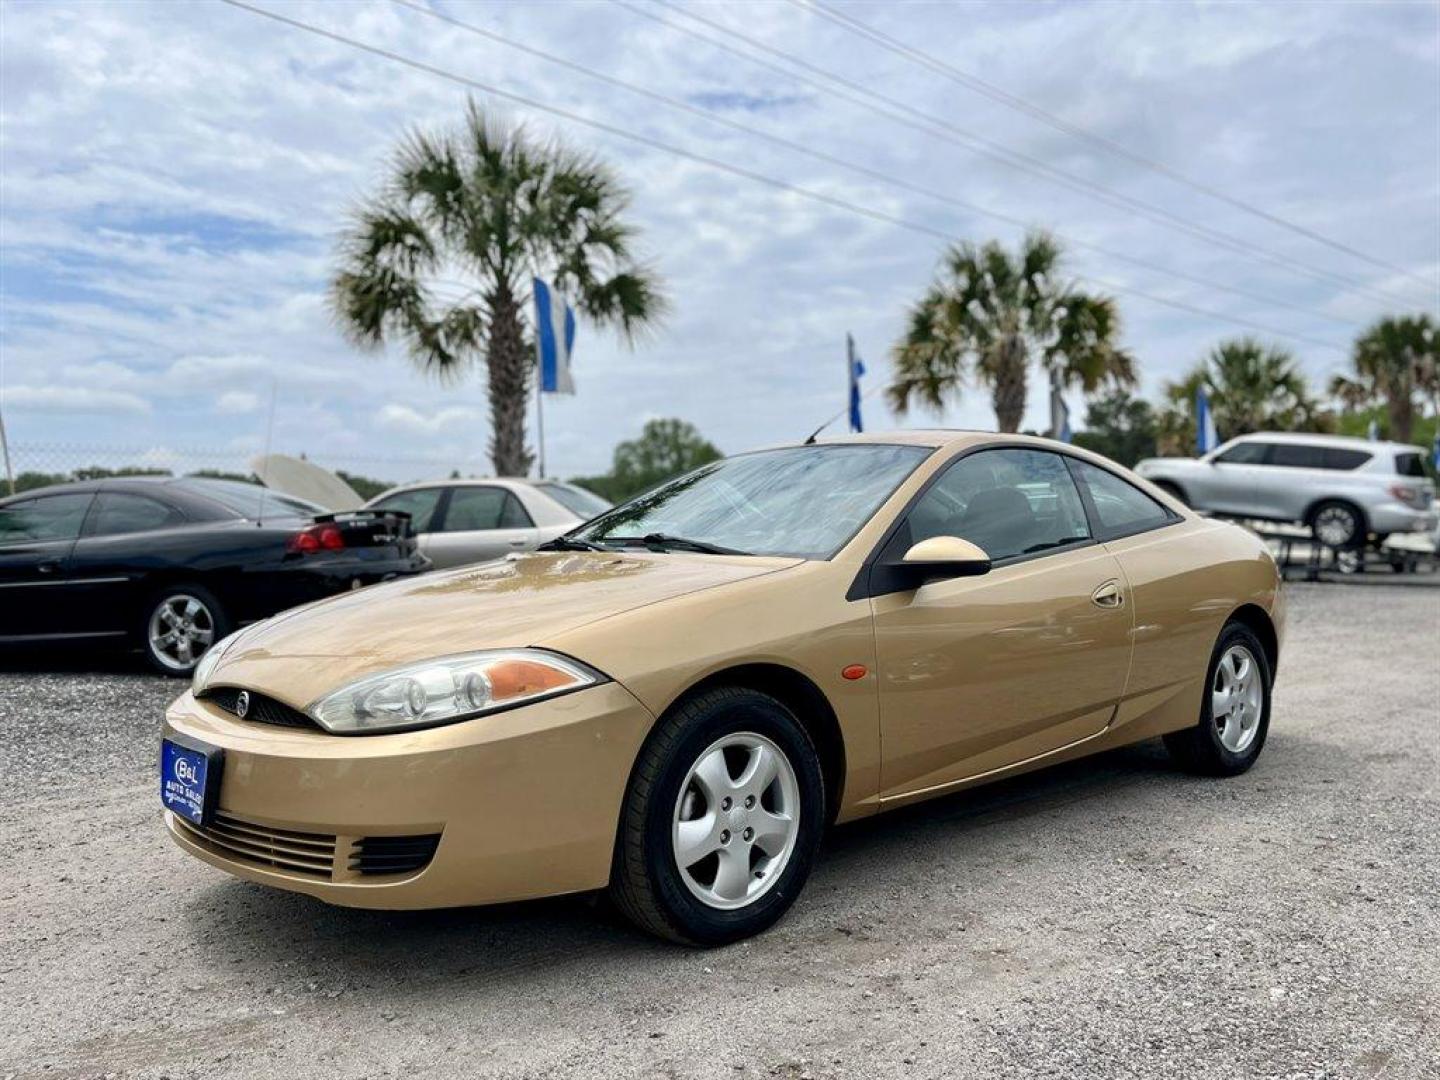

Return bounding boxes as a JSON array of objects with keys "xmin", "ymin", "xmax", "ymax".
[{"xmin": 1161, "ymin": 337, "xmax": 1329, "ymax": 452}]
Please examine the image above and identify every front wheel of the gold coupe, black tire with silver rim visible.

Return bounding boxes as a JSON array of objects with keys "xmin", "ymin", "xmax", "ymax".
[{"xmin": 611, "ymin": 687, "xmax": 825, "ymax": 946}]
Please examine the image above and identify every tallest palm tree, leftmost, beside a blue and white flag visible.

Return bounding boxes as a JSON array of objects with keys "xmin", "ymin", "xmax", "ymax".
[{"xmin": 331, "ymin": 101, "xmax": 665, "ymax": 477}]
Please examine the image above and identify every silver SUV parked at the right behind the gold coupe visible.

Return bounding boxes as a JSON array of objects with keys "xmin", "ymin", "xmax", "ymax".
[{"xmin": 1135, "ymin": 433, "xmax": 1436, "ymax": 547}]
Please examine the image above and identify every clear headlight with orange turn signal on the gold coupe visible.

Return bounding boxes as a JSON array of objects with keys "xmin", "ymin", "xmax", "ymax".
[{"xmin": 305, "ymin": 649, "xmax": 603, "ymax": 734}]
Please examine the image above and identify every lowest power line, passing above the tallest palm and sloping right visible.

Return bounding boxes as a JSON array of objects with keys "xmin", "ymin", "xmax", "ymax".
[{"xmin": 220, "ymin": 0, "xmax": 1346, "ymax": 353}]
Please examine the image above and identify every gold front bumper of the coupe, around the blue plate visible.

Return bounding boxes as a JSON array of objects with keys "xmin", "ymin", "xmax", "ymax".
[{"xmin": 164, "ymin": 683, "xmax": 654, "ymax": 909}]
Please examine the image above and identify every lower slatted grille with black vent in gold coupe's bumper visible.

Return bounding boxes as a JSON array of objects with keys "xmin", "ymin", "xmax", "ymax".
[{"xmin": 174, "ymin": 814, "xmax": 441, "ymax": 881}]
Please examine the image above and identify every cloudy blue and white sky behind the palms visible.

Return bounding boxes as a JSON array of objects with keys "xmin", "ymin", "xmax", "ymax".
[{"xmin": 0, "ymin": 0, "xmax": 1440, "ymax": 478}]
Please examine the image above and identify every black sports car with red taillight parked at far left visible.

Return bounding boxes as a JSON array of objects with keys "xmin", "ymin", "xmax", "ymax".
[{"xmin": 0, "ymin": 477, "xmax": 429, "ymax": 675}]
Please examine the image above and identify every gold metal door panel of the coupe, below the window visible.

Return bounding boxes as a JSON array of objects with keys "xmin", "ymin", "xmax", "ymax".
[{"xmin": 874, "ymin": 546, "xmax": 1130, "ymax": 798}]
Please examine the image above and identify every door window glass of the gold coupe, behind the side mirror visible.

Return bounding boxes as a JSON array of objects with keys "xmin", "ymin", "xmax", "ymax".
[{"xmin": 907, "ymin": 449, "xmax": 1090, "ymax": 560}]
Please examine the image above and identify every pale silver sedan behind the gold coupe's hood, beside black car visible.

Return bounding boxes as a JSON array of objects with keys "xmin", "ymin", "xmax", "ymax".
[{"xmin": 366, "ymin": 480, "xmax": 611, "ymax": 569}]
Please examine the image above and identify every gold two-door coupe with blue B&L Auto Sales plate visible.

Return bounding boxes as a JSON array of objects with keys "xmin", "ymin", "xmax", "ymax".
[{"xmin": 160, "ymin": 432, "xmax": 1284, "ymax": 945}]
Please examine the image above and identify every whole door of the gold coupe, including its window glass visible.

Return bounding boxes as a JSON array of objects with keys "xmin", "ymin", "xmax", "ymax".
[{"xmin": 871, "ymin": 448, "xmax": 1130, "ymax": 798}]
